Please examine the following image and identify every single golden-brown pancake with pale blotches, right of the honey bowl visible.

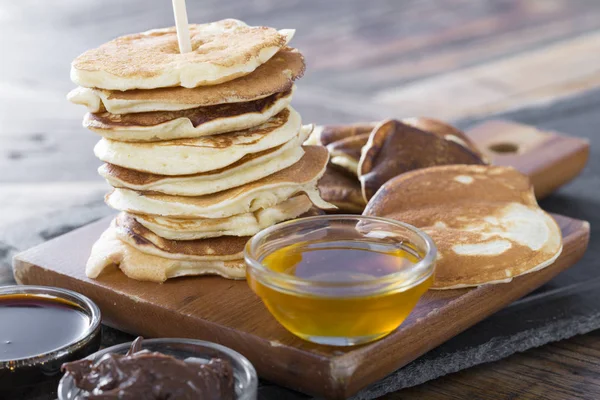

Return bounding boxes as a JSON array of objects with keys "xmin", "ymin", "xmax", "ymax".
[{"xmin": 364, "ymin": 165, "xmax": 562, "ymax": 289}]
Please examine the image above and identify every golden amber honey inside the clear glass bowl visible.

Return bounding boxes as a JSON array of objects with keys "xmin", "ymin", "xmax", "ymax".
[{"xmin": 248, "ymin": 238, "xmax": 432, "ymax": 345}]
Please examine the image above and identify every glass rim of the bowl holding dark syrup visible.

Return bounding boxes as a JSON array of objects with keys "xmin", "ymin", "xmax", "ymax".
[{"xmin": 0, "ymin": 285, "xmax": 102, "ymax": 369}]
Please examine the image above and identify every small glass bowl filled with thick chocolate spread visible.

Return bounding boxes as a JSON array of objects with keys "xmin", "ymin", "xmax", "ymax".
[{"xmin": 58, "ymin": 337, "xmax": 258, "ymax": 400}]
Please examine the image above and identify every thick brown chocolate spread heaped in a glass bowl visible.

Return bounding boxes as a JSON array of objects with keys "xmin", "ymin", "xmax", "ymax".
[{"xmin": 62, "ymin": 337, "xmax": 235, "ymax": 400}]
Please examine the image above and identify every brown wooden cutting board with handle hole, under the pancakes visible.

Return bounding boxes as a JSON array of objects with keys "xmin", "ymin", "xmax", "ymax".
[{"xmin": 14, "ymin": 122, "xmax": 589, "ymax": 398}]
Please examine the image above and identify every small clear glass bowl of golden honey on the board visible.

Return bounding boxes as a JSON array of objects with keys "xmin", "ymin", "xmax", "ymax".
[{"xmin": 245, "ymin": 215, "xmax": 437, "ymax": 346}]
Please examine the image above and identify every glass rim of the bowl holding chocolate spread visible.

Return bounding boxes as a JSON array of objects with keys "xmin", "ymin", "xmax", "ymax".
[{"xmin": 57, "ymin": 338, "xmax": 258, "ymax": 400}]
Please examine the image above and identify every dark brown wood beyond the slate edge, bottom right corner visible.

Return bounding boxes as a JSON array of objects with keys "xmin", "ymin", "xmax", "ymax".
[{"xmin": 394, "ymin": 331, "xmax": 600, "ymax": 400}]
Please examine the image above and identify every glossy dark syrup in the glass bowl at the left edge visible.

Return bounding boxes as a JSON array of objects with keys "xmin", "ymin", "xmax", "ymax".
[{"xmin": 0, "ymin": 294, "xmax": 101, "ymax": 392}]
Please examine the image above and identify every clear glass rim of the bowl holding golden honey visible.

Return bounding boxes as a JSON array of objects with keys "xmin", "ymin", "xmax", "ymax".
[{"xmin": 244, "ymin": 214, "xmax": 437, "ymax": 294}]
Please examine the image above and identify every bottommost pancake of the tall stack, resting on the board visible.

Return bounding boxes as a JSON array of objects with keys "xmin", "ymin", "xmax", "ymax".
[{"xmin": 85, "ymin": 222, "xmax": 246, "ymax": 283}]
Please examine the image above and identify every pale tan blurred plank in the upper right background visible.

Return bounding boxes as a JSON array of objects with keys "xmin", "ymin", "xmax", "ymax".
[{"xmin": 373, "ymin": 32, "xmax": 600, "ymax": 119}]
